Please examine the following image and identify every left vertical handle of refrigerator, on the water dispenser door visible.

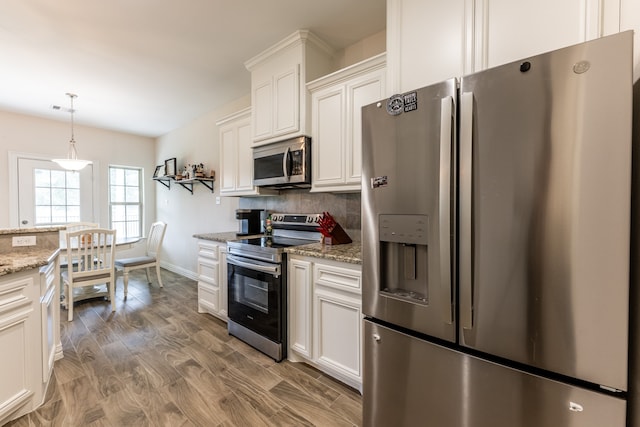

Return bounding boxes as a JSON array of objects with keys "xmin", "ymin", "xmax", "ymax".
[{"xmin": 438, "ymin": 96, "xmax": 454, "ymax": 325}]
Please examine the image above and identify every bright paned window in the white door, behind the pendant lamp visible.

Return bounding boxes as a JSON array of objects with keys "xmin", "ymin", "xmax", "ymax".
[{"xmin": 33, "ymin": 168, "xmax": 80, "ymax": 225}]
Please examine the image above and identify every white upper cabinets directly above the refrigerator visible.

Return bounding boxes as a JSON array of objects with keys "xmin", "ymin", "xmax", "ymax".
[{"xmin": 387, "ymin": 0, "xmax": 620, "ymax": 95}]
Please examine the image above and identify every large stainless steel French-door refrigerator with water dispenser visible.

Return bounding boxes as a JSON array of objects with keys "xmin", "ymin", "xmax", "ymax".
[{"xmin": 362, "ymin": 32, "xmax": 632, "ymax": 427}]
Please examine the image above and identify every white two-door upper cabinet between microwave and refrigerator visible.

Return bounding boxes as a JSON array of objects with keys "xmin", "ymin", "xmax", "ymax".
[{"xmin": 307, "ymin": 53, "xmax": 386, "ymax": 192}]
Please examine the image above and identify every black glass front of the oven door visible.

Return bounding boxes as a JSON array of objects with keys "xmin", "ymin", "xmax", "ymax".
[{"xmin": 227, "ymin": 264, "xmax": 282, "ymax": 342}]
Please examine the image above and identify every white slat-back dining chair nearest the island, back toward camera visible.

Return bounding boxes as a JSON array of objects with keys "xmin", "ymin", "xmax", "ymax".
[{"xmin": 62, "ymin": 228, "xmax": 116, "ymax": 321}]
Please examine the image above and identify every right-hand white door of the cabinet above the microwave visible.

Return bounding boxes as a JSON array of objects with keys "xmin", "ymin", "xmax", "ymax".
[{"xmin": 273, "ymin": 64, "xmax": 300, "ymax": 136}]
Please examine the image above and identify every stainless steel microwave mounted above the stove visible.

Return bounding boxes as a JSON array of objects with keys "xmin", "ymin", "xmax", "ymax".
[{"xmin": 253, "ymin": 136, "xmax": 311, "ymax": 189}]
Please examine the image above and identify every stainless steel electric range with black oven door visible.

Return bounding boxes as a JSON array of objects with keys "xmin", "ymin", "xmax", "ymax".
[{"xmin": 227, "ymin": 213, "xmax": 322, "ymax": 362}]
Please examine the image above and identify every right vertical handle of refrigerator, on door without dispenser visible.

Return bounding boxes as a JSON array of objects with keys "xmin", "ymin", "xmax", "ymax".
[{"xmin": 460, "ymin": 92, "xmax": 473, "ymax": 329}]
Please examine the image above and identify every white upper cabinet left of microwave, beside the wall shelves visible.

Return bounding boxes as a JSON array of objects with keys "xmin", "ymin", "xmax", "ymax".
[{"xmin": 216, "ymin": 108, "xmax": 260, "ymax": 196}]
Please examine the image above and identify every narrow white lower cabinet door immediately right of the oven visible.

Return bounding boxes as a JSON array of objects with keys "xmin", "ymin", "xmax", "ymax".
[{"xmin": 287, "ymin": 259, "xmax": 313, "ymax": 359}]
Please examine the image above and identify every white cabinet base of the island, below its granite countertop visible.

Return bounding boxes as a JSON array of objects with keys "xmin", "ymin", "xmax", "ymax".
[{"xmin": 0, "ymin": 258, "xmax": 62, "ymax": 425}]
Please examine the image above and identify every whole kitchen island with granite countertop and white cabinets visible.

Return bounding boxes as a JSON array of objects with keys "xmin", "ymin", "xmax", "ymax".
[{"xmin": 0, "ymin": 227, "xmax": 62, "ymax": 425}]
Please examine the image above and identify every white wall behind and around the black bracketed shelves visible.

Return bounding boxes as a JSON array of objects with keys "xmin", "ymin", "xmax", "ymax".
[{"xmin": 156, "ymin": 95, "xmax": 251, "ymax": 279}]
